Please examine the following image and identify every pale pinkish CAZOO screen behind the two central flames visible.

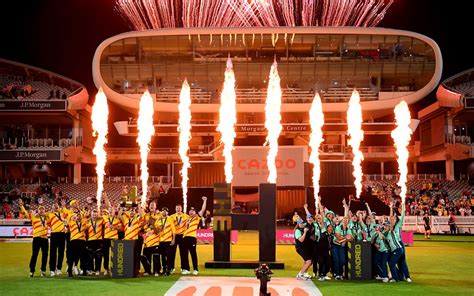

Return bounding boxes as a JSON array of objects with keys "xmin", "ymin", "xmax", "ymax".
[{"xmin": 232, "ymin": 146, "xmax": 308, "ymax": 186}]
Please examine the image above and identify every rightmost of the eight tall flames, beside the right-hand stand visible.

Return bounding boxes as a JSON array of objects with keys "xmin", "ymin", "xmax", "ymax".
[{"xmin": 392, "ymin": 101, "xmax": 413, "ymax": 204}]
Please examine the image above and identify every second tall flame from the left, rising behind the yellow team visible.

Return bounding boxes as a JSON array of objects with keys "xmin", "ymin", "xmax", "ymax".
[{"xmin": 137, "ymin": 91, "xmax": 155, "ymax": 207}]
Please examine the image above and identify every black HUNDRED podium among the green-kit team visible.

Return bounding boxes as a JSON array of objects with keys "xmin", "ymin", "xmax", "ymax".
[{"xmin": 348, "ymin": 241, "xmax": 372, "ymax": 281}]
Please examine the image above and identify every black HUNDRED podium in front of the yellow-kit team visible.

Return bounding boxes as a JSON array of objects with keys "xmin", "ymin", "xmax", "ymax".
[{"xmin": 111, "ymin": 239, "xmax": 140, "ymax": 279}]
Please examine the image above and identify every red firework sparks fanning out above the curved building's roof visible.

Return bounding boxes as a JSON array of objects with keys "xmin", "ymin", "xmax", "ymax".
[{"xmin": 115, "ymin": 0, "xmax": 393, "ymax": 30}]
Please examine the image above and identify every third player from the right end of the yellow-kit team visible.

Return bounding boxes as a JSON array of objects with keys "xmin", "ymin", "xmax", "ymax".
[{"xmin": 158, "ymin": 207, "xmax": 176, "ymax": 275}]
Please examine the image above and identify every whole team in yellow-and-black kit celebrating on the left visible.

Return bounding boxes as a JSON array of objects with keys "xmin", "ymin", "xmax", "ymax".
[{"xmin": 20, "ymin": 197, "xmax": 207, "ymax": 277}]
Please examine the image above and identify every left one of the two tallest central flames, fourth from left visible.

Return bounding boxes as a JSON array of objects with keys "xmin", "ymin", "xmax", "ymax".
[{"xmin": 217, "ymin": 58, "xmax": 237, "ymax": 183}]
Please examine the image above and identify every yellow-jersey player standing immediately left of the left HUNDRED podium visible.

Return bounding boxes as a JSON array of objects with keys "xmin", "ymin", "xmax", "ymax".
[{"xmin": 102, "ymin": 207, "xmax": 123, "ymax": 275}]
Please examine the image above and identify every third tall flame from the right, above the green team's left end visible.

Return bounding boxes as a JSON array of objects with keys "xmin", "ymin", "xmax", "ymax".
[{"xmin": 309, "ymin": 93, "xmax": 324, "ymax": 209}]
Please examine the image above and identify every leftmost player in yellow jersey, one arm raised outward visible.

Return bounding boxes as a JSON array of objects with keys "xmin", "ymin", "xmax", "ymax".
[{"xmin": 19, "ymin": 199, "xmax": 48, "ymax": 277}]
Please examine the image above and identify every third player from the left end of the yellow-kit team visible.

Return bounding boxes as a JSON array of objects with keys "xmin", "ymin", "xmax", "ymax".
[{"xmin": 67, "ymin": 211, "xmax": 88, "ymax": 277}]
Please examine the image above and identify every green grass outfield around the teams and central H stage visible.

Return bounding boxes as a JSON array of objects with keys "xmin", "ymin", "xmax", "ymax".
[{"xmin": 0, "ymin": 232, "xmax": 474, "ymax": 296}]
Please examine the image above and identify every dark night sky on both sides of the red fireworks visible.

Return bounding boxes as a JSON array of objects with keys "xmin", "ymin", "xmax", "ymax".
[{"xmin": 0, "ymin": 0, "xmax": 468, "ymax": 146}]
